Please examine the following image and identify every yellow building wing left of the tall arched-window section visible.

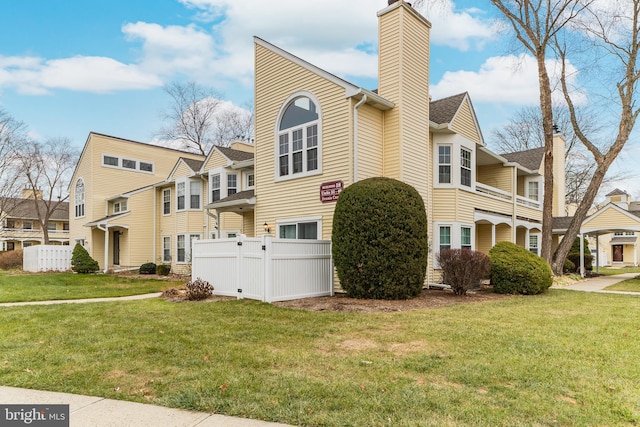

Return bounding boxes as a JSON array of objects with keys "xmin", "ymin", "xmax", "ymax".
[{"xmin": 70, "ymin": 132, "xmax": 253, "ymax": 272}]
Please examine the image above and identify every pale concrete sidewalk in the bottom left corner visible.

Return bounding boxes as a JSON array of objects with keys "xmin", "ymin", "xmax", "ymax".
[{"xmin": 0, "ymin": 386, "xmax": 296, "ymax": 427}]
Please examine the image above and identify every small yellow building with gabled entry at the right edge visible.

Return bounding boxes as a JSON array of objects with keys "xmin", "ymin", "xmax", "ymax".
[{"xmin": 554, "ymin": 188, "xmax": 640, "ymax": 268}]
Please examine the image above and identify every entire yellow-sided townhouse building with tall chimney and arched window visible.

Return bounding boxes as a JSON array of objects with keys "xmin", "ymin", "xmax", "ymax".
[{"xmin": 70, "ymin": 0, "xmax": 565, "ymax": 283}]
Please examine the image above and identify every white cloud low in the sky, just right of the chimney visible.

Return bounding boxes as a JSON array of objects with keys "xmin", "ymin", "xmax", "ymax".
[{"xmin": 431, "ymin": 54, "xmax": 587, "ymax": 106}]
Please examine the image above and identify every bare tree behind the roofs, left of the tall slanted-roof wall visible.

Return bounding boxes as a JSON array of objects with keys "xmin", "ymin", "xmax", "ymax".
[{"xmin": 157, "ymin": 82, "xmax": 253, "ymax": 155}]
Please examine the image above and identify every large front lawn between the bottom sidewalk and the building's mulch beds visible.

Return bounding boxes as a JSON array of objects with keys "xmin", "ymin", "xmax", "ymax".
[{"xmin": 0, "ymin": 290, "xmax": 640, "ymax": 426}]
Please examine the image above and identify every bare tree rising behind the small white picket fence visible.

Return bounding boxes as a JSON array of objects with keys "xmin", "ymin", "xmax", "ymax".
[{"xmin": 16, "ymin": 138, "xmax": 78, "ymax": 245}]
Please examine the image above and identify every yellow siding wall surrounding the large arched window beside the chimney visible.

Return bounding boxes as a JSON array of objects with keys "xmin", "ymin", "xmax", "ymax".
[{"xmin": 255, "ymin": 44, "xmax": 352, "ymax": 239}]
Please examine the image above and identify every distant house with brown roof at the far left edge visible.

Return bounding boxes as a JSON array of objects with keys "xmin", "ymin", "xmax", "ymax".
[{"xmin": 0, "ymin": 189, "xmax": 69, "ymax": 251}]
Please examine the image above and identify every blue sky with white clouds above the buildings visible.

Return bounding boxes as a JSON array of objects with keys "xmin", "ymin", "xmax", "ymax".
[{"xmin": 0, "ymin": 0, "xmax": 634, "ymax": 197}]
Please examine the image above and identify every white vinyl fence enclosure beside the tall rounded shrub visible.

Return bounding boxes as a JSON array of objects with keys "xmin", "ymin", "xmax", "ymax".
[{"xmin": 191, "ymin": 235, "xmax": 333, "ymax": 302}]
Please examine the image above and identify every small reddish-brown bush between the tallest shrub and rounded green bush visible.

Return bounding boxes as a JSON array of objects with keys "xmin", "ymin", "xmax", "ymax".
[{"xmin": 436, "ymin": 249, "xmax": 491, "ymax": 295}]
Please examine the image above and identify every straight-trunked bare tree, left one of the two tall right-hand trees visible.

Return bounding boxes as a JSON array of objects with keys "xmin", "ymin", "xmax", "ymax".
[{"xmin": 491, "ymin": 0, "xmax": 593, "ymax": 265}]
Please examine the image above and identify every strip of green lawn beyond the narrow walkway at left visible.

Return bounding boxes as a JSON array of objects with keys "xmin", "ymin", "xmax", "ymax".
[{"xmin": 0, "ymin": 272, "xmax": 185, "ymax": 303}]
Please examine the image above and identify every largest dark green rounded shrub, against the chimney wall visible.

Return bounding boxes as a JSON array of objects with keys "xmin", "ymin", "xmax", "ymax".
[{"xmin": 332, "ymin": 178, "xmax": 429, "ymax": 299}]
